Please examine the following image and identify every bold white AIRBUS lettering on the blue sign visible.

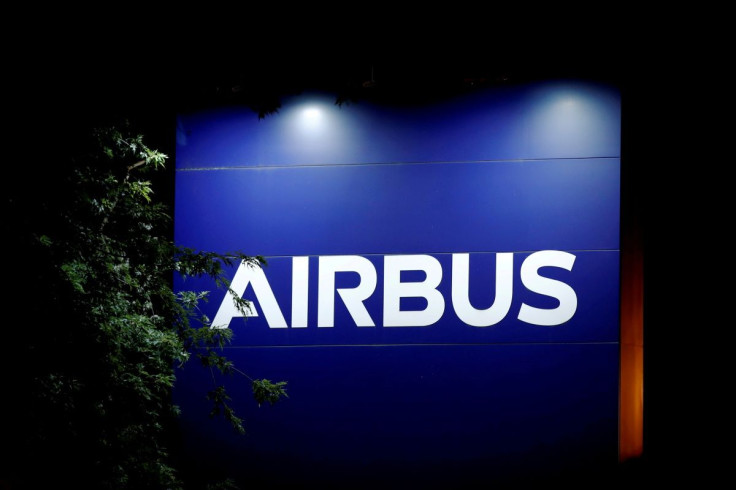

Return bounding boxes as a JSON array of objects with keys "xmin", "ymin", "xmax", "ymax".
[{"xmin": 212, "ymin": 250, "xmax": 578, "ymax": 328}]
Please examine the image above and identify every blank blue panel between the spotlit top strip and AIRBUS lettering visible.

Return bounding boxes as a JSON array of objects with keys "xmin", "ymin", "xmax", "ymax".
[{"xmin": 176, "ymin": 159, "xmax": 619, "ymax": 256}]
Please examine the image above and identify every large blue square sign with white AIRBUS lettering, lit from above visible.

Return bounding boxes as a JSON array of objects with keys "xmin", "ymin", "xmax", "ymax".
[{"xmin": 175, "ymin": 82, "xmax": 620, "ymax": 484}]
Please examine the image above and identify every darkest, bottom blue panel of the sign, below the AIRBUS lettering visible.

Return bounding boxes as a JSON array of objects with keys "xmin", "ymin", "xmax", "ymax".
[{"xmin": 177, "ymin": 344, "xmax": 618, "ymax": 488}]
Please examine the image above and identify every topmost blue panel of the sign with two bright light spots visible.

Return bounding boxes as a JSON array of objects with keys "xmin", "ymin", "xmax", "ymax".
[{"xmin": 176, "ymin": 82, "xmax": 621, "ymax": 169}]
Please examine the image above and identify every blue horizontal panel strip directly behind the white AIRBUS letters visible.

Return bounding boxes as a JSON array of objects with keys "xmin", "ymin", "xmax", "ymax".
[{"xmin": 177, "ymin": 251, "xmax": 619, "ymax": 346}]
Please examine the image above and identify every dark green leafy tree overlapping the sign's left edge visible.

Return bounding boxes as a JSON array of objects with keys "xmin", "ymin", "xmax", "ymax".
[{"xmin": 5, "ymin": 124, "xmax": 286, "ymax": 488}]
